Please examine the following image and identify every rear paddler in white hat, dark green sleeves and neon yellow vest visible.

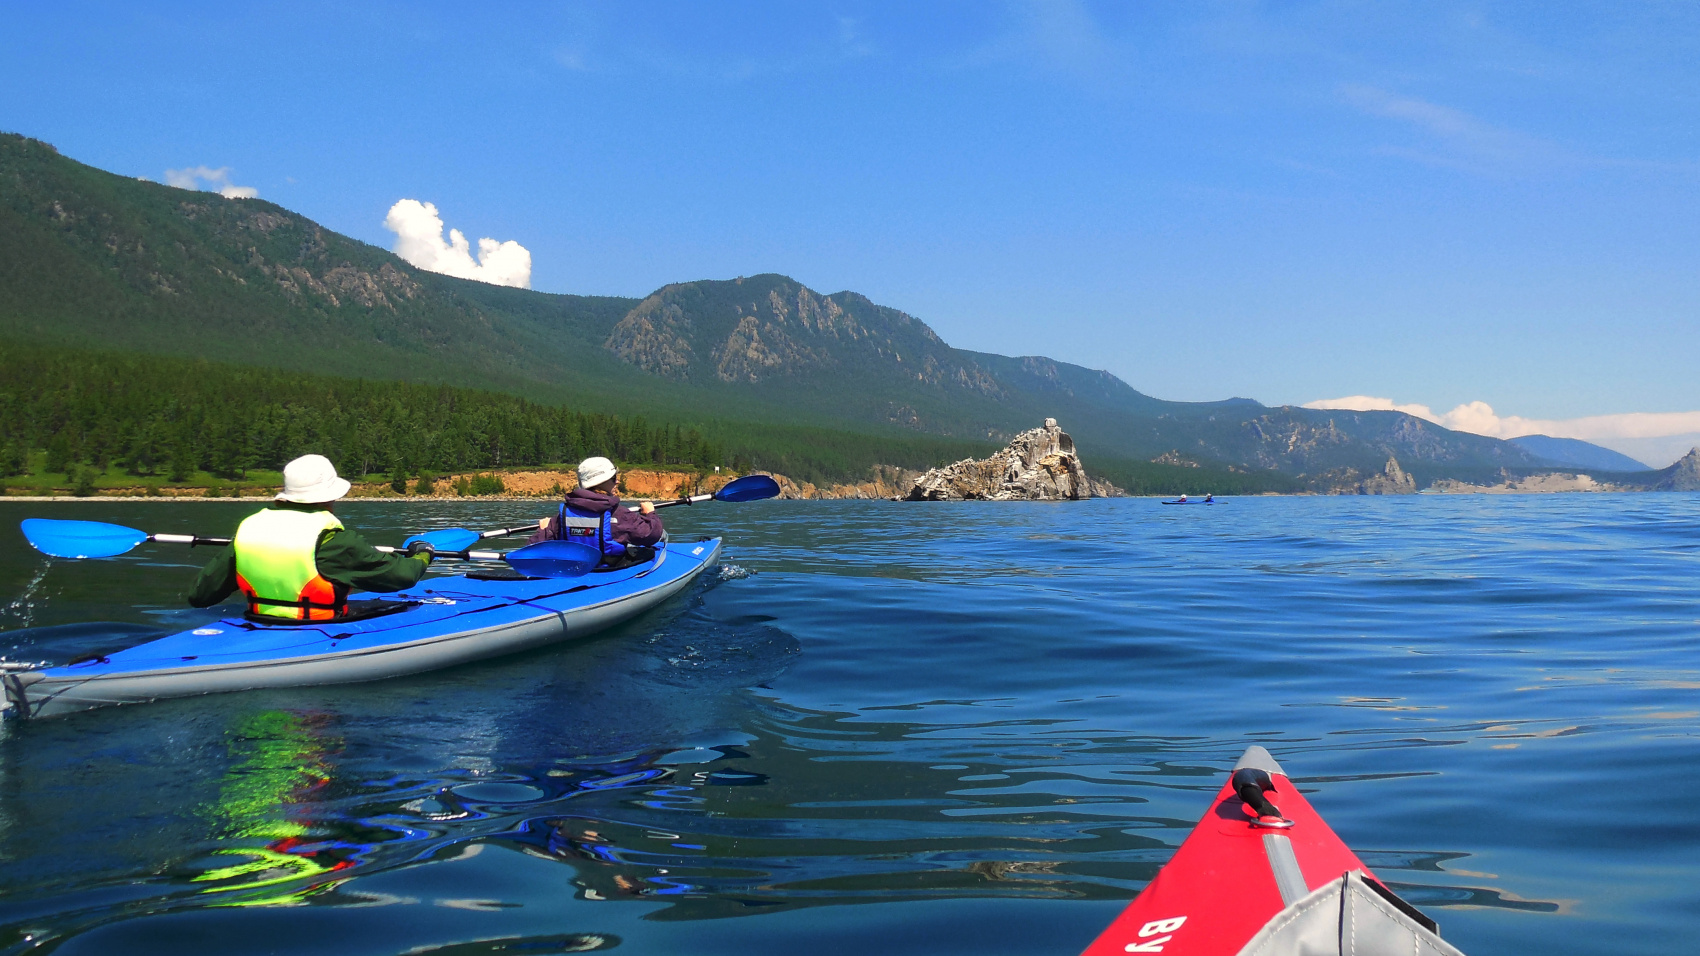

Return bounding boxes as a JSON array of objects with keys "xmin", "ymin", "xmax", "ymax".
[{"xmin": 189, "ymin": 454, "xmax": 434, "ymax": 621}]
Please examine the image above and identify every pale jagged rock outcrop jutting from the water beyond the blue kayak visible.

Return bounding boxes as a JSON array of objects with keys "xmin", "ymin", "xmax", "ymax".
[{"xmin": 904, "ymin": 418, "xmax": 1122, "ymax": 502}]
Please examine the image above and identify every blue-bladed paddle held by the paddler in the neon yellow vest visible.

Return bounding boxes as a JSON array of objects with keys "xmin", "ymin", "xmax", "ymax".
[{"xmin": 19, "ymin": 517, "xmax": 602, "ymax": 578}]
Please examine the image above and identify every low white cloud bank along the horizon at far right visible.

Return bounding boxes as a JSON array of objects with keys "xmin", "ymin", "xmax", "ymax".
[{"xmin": 1304, "ymin": 395, "xmax": 1700, "ymax": 468}]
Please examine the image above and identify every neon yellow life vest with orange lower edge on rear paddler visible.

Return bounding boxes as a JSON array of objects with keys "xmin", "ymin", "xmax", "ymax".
[{"xmin": 231, "ymin": 509, "xmax": 349, "ymax": 621}]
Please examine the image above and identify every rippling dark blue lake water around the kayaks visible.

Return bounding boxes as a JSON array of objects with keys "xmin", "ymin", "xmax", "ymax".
[{"xmin": 0, "ymin": 495, "xmax": 1700, "ymax": 956}]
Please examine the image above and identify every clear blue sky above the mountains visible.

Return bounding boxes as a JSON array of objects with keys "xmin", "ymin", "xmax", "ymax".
[{"xmin": 0, "ymin": 2, "xmax": 1700, "ymax": 464}]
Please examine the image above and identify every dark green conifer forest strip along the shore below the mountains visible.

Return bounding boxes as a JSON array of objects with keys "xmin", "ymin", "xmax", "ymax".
[{"xmin": 0, "ymin": 344, "xmax": 991, "ymax": 485}]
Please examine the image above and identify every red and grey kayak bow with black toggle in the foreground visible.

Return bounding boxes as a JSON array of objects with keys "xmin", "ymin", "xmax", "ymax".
[{"xmin": 1083, "ymin": 747, "xmax": 1462, "ymax": 956}]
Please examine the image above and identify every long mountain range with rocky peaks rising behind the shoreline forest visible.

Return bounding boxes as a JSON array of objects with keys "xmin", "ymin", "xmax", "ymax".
[{"xmin": 0, "ymin": 134, "xmax": 1641, "ymax": 490}]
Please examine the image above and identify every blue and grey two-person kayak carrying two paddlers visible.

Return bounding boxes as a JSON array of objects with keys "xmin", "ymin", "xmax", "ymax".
[{"xmin": 0, "ymin": 538, "xmax": 721, "ymax": 718}]
